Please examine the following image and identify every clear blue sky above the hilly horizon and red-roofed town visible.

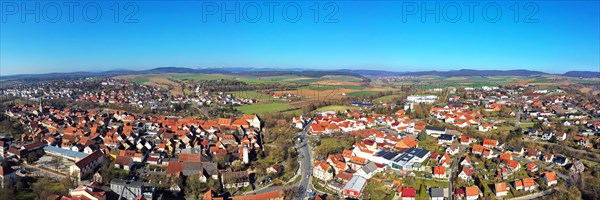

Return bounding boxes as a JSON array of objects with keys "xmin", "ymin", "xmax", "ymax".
[{"xmin": 0, "ymin": 1, "xmax": 600, "ymax": 75}]
